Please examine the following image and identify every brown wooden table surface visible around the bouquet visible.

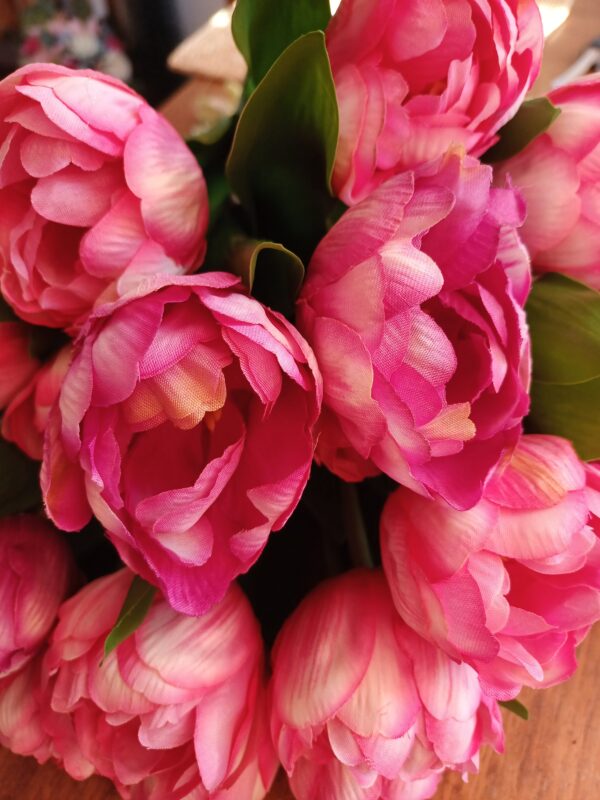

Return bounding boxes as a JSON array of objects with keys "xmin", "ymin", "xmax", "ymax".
[{"xmin": 0, "ymin": 0, "xmax": 600, "ymax": 800}]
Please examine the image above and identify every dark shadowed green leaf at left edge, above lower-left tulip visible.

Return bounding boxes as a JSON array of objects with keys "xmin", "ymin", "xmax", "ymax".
[{"xmin": 0, "ymin": 439, "xmax": 42, "ymax": 517}]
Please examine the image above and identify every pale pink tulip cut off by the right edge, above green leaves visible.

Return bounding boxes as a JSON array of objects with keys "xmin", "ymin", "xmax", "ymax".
[{"xmin": 496, "ymin": 75, "xmax": 600, "ymax": 289}]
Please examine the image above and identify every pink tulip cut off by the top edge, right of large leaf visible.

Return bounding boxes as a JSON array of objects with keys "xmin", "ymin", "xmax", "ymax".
[{"xmin": 327, "ymin": 0, "xmax": 543, "ymax": 205}]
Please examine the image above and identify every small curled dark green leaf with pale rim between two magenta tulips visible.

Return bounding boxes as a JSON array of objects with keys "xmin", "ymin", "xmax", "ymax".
[{"xmin": 230, "ymin": 240, "xmax": 304, "ymax": 317}]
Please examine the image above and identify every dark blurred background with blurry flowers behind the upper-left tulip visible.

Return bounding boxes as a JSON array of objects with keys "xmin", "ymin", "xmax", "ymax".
[{"xmin": 0, "ymin": 0, "xmax": 227, "ymax": 105}]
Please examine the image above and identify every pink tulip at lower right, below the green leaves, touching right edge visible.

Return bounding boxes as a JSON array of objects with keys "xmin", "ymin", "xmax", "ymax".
[{"xmin": 381, "ymin": 435, "xmax": 600, "ymax": 699}]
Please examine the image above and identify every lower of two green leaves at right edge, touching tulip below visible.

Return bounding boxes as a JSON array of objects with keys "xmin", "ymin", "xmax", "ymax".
[{"xmin": 525, "ymin": 377, "xmax": 600, "ymax": 461}]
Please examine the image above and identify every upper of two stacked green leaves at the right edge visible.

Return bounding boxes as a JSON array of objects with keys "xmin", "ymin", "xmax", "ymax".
[{"xmin": 527, "ymin": 275, "xmax": 600, "ymax": 384}]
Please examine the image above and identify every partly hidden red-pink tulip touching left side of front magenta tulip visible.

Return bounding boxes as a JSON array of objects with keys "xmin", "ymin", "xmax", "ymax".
[{"xmin": 2, "ymin": 345, "xmax": 72, "ymax": 461}]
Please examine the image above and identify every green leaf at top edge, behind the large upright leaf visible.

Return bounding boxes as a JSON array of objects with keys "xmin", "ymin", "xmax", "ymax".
[{"xmin": 231, "ymin": 0, "xmax": 331, "ymax": 86}]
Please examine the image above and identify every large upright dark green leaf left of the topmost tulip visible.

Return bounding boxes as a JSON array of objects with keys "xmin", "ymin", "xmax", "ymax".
[{"xmin": 226, "ymin": 32, "xmax": 338, "ymax": 263}]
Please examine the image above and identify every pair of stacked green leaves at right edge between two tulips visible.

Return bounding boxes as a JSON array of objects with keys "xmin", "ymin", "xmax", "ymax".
[{"xmin": 526, "ymin": 275, "xmax": 600, "ymax": 461}]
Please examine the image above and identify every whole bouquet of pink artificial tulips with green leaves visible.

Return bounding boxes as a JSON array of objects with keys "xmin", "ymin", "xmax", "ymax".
[{"xmin": 0, "ymin": 0, "xmax": 600, "ymax": 800}]
